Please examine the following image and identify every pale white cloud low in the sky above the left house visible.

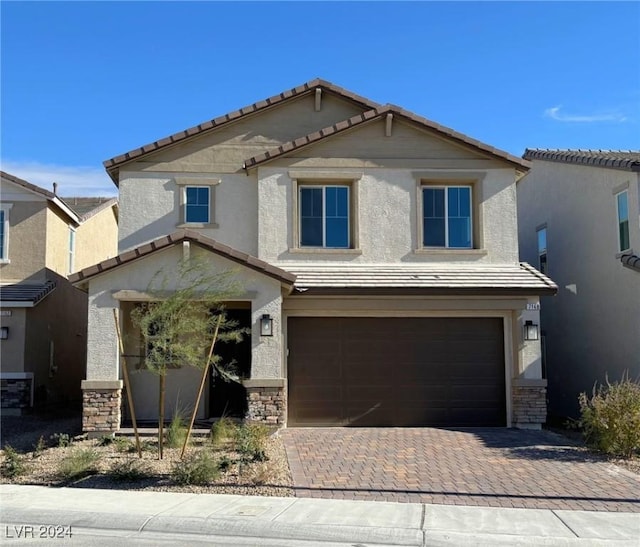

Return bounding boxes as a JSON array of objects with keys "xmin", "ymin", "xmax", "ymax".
[{"xmin": 2, "ymin": 160, "xmax": 118, "ymax": 197}]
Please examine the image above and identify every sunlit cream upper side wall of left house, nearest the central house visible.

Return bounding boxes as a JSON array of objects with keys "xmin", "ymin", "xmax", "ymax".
[{"xmin": 74, "ymin": 207, "xmax": 118, "ymax": 271}]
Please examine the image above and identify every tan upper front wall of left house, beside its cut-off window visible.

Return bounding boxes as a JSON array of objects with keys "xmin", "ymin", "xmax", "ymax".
[{"xmin": 0, "ymin": 201, "xmax": 47, "ymax": 283}]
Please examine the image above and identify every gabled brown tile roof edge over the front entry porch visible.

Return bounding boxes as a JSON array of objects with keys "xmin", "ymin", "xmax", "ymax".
[{"xmin": 69, "ymin": 229, "xmax": 295, "ymax": 285}]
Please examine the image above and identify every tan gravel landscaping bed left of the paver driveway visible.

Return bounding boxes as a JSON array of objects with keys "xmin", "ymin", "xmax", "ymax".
[{"xmin": 0, "ymin": 414, "xmax": 294, "ymax": 497}]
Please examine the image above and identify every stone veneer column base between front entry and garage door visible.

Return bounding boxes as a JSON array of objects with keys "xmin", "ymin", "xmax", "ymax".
[{"xmin": 243, "ymin": 379, "xmax": 287, "ymax": 427}]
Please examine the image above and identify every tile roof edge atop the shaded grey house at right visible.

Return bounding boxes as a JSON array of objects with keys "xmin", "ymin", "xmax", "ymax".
[{"xmin": 522, "ymin": 148, "xmax": 640, "ymax": 171}]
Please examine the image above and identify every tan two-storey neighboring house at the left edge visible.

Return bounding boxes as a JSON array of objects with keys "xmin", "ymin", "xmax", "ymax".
[{"xmin": 0, "ymin": 172, "xmax": 118, "ymax": 414}]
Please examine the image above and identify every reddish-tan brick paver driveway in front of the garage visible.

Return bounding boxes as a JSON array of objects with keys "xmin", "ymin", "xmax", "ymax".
[{"xmin": 281, "ymin": 428, "xmax": 640, "ymax": 512}]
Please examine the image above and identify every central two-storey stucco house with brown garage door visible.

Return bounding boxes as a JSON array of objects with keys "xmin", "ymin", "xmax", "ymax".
[{"xmin": 72, "ymin": 80, "xmax": 556, "ymax": 434}]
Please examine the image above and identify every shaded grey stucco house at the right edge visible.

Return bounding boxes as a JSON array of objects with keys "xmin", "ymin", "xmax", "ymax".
[{"xmin": 518, "ymin": 150, "xmax": 640, "ymax": 418}]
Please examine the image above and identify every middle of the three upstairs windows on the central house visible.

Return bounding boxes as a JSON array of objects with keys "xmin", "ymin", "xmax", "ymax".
[{"xmin": 298, "ymin": 185, "xmax": 351, "ymax": 249}]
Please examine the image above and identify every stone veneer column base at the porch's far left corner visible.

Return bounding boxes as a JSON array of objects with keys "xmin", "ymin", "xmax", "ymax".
[{"xmin": 82, "ymin": 380, "xmax": 122, "ymax": 438}]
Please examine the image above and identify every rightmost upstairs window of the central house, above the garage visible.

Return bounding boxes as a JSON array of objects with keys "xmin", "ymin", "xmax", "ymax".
[{"xmin": 422, "ymin": 186, "xmax": 473, "ymax": 249}]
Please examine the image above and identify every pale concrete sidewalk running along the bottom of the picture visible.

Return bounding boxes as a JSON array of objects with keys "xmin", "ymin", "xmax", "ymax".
[{"xmin": 0, "ymin": 484, "xmax": 640, "ymax": 547}]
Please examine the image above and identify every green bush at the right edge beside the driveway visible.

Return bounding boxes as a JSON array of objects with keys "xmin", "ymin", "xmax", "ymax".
[{"xmin": 578, "ymin": 374, "xmax": 640, "ymax": 458}]
